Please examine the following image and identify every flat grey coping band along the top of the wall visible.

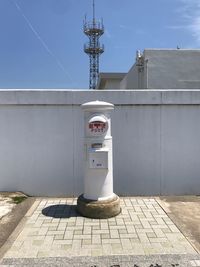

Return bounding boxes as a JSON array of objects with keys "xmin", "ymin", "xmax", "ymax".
[{"xmin": 0, "ymin": 89, "xmax": 200, "ymax": 105}]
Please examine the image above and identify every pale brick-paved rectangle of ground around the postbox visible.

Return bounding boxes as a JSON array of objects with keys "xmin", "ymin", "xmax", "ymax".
[{"xmin": 4, "ymin": 197, "xmax": 197, "ymax": 258}]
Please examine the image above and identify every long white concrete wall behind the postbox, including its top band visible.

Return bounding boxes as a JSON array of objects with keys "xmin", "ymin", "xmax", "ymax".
[{"xmin": 0, "ymin": 90, "xmax": 200, "ymax": 196}]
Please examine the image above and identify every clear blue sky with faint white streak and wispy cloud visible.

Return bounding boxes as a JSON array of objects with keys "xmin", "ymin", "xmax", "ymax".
[{"xmin": 0, "ymin": 0, "xmax": 200, "ymax": 89}]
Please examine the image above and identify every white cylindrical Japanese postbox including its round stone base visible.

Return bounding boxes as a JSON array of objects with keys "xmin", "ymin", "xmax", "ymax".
[{"xmin": 77, "ymin": 101, "xmax": 120, "ymax": 218}]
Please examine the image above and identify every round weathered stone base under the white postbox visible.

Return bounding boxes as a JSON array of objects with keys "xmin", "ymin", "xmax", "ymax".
[{"xmin": 77, "ymin": 194, "xmax": 121, "ymax": 219}]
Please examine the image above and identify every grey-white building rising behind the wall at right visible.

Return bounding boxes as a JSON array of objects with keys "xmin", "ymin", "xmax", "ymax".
[{"xmin": 97, "ymin": 49, "xmax": 200, "ymax": 90}]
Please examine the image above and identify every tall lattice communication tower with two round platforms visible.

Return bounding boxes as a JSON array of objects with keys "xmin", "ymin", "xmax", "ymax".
[{"xmin": 83, "ymin": 0, "xmax": 104, "ymax": 89}]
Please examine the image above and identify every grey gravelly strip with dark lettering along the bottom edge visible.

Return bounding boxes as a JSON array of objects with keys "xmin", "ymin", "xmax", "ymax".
[{"xmin": 0, "ymin": 255, "xmax": 200, "ymax": 267}]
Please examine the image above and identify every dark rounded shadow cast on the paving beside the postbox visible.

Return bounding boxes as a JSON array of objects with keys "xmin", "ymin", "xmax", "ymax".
[{"xmin": 42, "ymin": 204, "xmax": 81, "ymax": 219}]
